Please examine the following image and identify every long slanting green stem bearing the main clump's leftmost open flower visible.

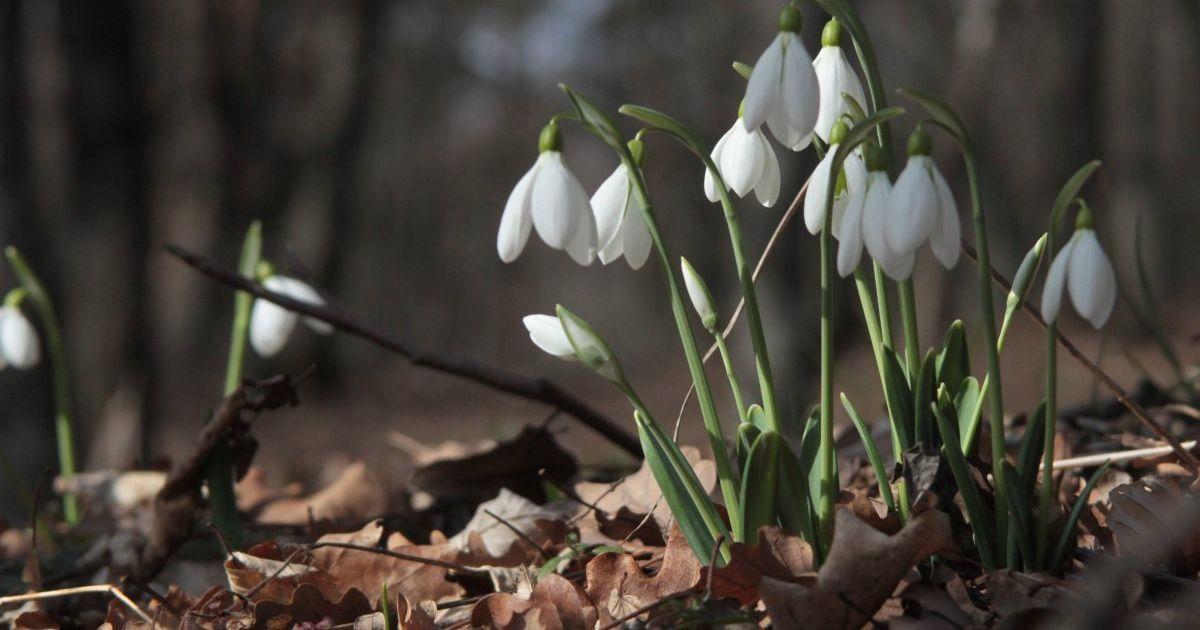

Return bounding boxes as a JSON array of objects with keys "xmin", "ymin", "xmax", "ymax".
[{"xmin": 622, "ymin": 170, "xmax": 750, "ymax": 522}]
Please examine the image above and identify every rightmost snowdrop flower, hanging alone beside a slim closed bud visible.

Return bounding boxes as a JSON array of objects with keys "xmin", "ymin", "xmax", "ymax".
[{"xmin": 1042, "ymin": 202, "xmax": 1117, "ymax": 330}]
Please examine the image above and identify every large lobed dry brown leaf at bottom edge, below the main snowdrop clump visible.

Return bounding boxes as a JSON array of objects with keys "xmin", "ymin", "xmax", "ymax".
[{"xmin": 758, "ymin": 508, "xmax": 954, "ymax": 629}]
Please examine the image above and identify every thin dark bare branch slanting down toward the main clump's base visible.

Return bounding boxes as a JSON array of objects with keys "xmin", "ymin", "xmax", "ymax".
[{"xmin": 166, "ymin": 244, "xmax": 642, "ymax": 458}]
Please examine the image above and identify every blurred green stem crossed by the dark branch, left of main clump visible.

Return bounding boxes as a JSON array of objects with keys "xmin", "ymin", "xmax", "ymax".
[{"xmin": 206, "ymin": 221, "xmax": 263, "ymax": 547}]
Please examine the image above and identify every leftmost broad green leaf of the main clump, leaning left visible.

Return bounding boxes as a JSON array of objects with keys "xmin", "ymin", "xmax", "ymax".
[{"xmin": 634, "ymin": 412, "xmax": 730, "ymax": 563}]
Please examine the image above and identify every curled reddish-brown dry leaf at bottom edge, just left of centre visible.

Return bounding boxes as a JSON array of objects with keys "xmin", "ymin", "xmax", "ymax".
[{"xmin": 470, "ymin": 574, "xmax": 598, "ymax": 630}]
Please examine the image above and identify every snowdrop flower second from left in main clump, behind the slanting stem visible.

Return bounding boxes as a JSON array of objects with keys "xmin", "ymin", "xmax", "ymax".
[{"xmin": 592, "ymin": 139, "xmax": 653, "ymax": 269}]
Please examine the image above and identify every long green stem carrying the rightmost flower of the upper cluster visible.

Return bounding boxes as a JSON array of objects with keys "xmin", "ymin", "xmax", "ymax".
[{"xmin": 962, "ymin": 154, "xmax": 1008, "ymax": 556}]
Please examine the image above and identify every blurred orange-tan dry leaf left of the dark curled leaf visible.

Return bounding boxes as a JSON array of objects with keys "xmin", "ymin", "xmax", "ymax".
[{"xmin": 258, "ymin": 462, "xmax": 388, "ymax": 524}]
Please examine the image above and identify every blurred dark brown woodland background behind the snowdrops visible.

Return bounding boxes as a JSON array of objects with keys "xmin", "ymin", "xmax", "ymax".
[{"xmin": 0, "ymin": 0, "xmax": 1200, "ymax": 515}]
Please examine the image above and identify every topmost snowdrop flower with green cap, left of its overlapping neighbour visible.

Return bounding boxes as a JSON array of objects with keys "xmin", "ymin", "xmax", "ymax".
[{"xmin": 742, "ymin": 5, "xmax": 821, "ymax": 151}]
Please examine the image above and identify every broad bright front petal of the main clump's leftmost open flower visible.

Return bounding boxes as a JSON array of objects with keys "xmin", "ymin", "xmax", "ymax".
[{"xmin": 530, "ymin": 151, "xmax": 588, "ymax": 250}]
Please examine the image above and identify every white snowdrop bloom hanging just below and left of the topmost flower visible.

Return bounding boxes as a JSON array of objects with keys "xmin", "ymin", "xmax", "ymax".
[{"xmin": 704, "ymin": 118, "xmax": 780, "ymax": 208}]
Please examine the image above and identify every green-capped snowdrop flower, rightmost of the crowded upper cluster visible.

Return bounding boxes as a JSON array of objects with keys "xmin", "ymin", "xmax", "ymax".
[{"xmin": 884, "ymin": 126, "xmax": 961, "ymax": 269}]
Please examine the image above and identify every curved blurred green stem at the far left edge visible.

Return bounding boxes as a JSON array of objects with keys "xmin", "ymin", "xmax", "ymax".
[{"xmin": 5, "ymin": 246, "xmax": 79, "ymax": 526}]
